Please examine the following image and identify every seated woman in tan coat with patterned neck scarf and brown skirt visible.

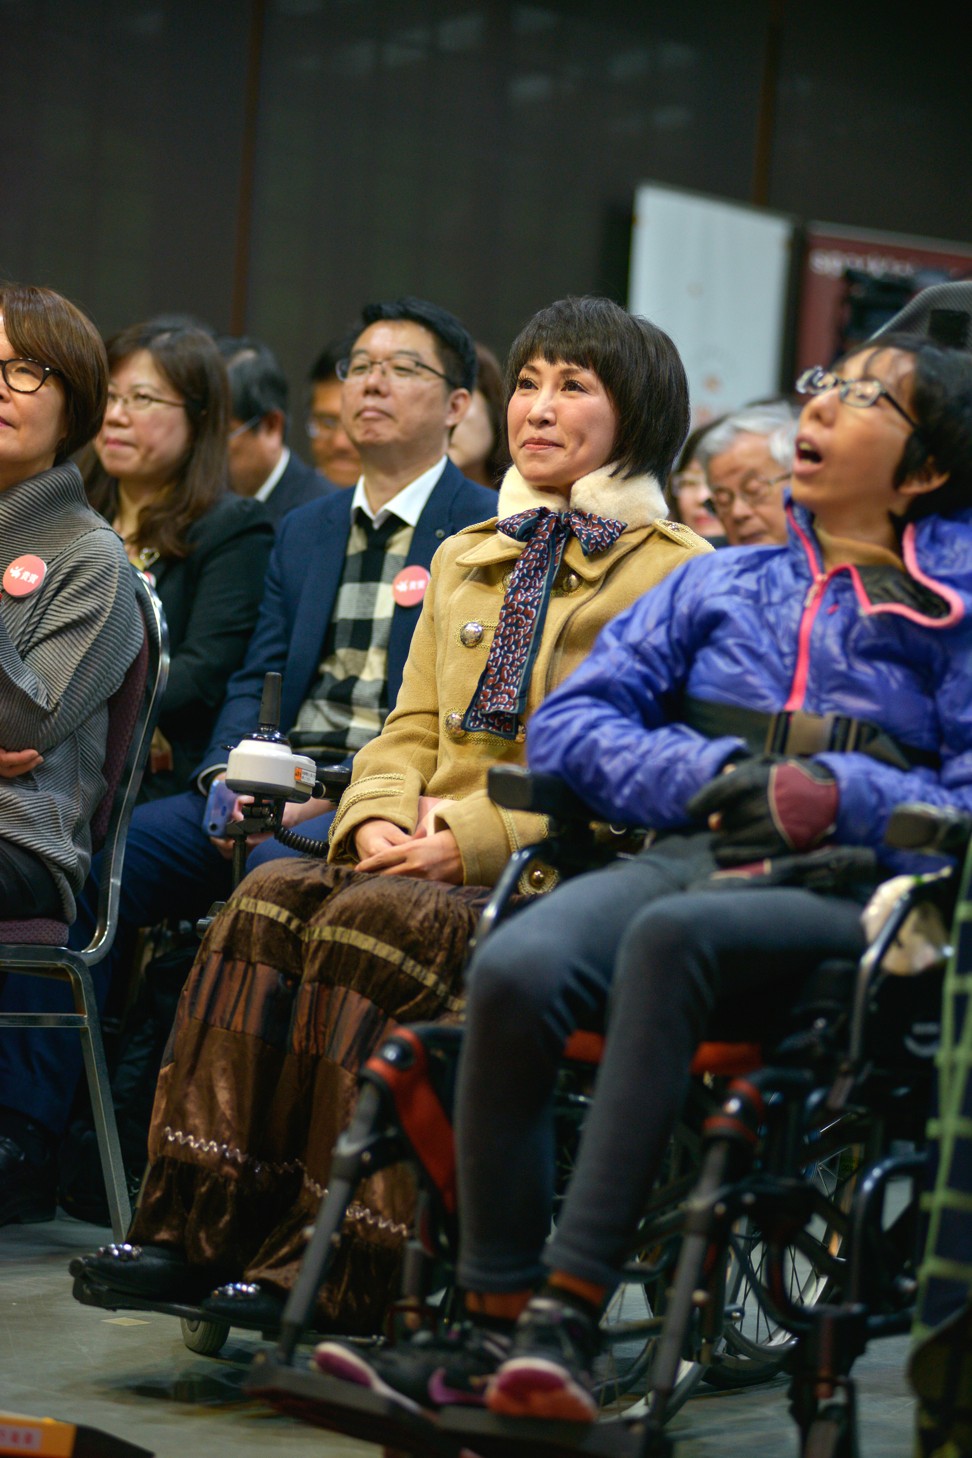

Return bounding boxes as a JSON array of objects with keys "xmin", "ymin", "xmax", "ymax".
[{"xmin": 76, "ymin": 299, "xmax": 708, "ymax": 1333}]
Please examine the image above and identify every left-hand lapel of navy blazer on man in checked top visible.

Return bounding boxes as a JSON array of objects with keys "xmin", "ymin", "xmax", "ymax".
[{"xmin": 280, "ymin": 490, "xmax": 354, "ymax": 725}]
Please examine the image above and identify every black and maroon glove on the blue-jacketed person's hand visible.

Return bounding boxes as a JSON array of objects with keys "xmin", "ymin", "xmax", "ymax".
[{"xmin": 688, "ymin": 760, "xmax": 839, "ymax": 866}]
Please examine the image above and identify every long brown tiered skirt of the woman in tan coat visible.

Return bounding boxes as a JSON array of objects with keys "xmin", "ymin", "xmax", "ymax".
[{"xmin": 130, "ymin": 859, "xmax": 488, "ymax": 1333}]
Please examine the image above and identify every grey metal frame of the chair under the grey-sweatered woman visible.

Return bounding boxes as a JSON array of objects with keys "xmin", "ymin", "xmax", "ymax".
[{"xmin": 0, "ymin": 569, "xmax": 169, "ymax": 1239}]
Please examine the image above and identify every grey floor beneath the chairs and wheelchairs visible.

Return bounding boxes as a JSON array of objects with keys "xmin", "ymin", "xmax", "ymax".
[{"xmin": 0, "ymin": 1216, "xmax": 912, "ymax": 1458}]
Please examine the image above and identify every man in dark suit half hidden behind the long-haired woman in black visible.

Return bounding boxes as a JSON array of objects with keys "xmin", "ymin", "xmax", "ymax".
[{"xmin": 216, "ymin": 334, "xmax": 338, "ymax": 526}]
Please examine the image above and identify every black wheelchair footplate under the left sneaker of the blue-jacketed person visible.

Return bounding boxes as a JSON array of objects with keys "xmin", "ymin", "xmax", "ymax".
[{"xmin": 243, "ymin": 1352, "xmax": 472, "ymax": 1458}]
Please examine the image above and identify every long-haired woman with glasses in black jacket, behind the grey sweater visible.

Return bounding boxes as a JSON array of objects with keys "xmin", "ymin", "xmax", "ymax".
[{"xmin": 86, "ymin": 319, "xmax": 273, "ymax": 799}]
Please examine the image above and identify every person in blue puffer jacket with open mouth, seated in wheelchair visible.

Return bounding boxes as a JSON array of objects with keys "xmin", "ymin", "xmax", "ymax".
[{"xmin": 318, "ymin": 325, "xmax": 972, "ymax": 1420}]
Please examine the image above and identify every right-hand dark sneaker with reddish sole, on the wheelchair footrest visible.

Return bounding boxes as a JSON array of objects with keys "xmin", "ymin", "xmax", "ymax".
[{"xmin": 487, "ymin": 1296, "xmax": 600, "ymax": 1423}]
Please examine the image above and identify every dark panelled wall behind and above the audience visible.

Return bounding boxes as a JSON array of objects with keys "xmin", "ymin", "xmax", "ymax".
[{"xmin": 0, "ymin": 0, "xmax": 972, "ymax": 446}]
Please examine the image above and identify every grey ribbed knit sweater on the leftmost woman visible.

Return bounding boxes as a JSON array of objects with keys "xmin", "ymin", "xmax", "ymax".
[{"xmin": 0, "ymin": 464, "xmax": 143, "ymax": 920}]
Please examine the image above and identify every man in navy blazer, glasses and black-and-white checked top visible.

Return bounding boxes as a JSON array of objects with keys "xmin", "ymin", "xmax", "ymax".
[{"xmin": 0, "ymin": 299, "xmax": 497, "ymax": 1207}]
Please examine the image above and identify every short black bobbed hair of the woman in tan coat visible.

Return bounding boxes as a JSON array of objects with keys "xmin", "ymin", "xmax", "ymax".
[{"xmin": 506, "ymin": 295, "xmax": 689, "ymax": 486}]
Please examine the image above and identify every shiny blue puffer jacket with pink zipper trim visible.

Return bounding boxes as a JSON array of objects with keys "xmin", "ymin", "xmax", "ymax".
[{"xmin": 528, "ymin": 504, "xmax": 972, "ymax": 869}]
